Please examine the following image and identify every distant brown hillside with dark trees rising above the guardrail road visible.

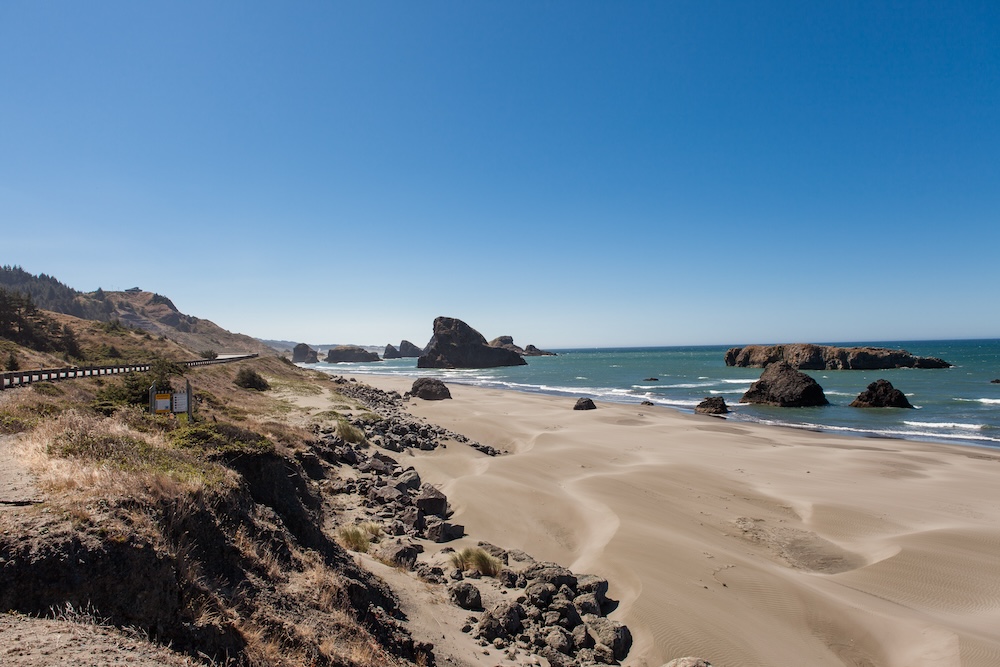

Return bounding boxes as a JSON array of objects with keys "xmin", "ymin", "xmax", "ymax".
[{"xmin": 0, "ymin": 266, "xmax": 276, "ymax": 355}]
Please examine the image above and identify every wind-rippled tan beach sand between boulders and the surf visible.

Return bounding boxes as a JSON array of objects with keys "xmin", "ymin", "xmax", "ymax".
[{"xmin": 344, "ymin": 376, "xmax": 1000, "ymax": 667}]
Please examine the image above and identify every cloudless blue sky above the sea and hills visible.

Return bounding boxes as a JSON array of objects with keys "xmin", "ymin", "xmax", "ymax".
[{"xmin": 0, "ymin": 0, "xmax": 1000, "ymax": 348}]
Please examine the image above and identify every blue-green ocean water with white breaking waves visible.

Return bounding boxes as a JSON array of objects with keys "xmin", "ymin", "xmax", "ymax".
[{"xmin": 310, "ymin": 340, "xmax": 1000, "ymax": 447}]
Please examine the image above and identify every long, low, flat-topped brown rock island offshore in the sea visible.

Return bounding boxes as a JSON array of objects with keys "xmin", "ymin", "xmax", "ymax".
[{"xmin": 726, "ymin": 343, "xmax": 951, "ymax": 371}]
